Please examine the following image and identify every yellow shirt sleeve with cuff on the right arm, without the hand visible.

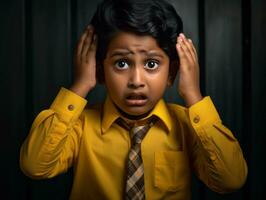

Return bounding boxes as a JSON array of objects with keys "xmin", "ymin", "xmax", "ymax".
[{"xmin": 187, "ymin": 97, "xmax": 247, "ymax": 193}]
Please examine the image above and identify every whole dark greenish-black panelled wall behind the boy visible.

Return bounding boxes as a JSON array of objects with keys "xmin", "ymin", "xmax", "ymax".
[{"xmin": 0, "ymin": 0, "xmax": 266, "ymax": 200}]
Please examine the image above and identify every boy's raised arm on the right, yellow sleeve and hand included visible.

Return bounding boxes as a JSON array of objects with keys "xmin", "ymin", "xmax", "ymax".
[{"xmin": 176, "ymin": 34, "xmax": 247, "ymax": 193}]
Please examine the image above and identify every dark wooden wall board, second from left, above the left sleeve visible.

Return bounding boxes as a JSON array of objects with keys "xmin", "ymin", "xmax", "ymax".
[{"xmin": 28, "ymin": 0, "xmax": 72, "ymax": 114}]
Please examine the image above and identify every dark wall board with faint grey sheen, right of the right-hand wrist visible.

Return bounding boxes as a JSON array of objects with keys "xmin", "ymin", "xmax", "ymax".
[{"xmin": 204, "ymin": 0, "xmax": 244, "ymax": 200}]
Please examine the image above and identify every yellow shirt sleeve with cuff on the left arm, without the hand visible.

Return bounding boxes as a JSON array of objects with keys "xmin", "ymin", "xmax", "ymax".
[{"xmin": 20, "ymin": 88, "xmax": 87, "ymax": 179}]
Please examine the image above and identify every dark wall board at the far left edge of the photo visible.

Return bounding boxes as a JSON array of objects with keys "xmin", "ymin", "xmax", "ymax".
[{"xmin": 0, "ymin": 0, "xmax": 27, "ymax": 199}]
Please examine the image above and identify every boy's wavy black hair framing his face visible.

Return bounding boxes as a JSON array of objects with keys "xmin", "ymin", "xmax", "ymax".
[{"xmin": 91, "ymin": 0, "xmax": 183, "ymax": 83}]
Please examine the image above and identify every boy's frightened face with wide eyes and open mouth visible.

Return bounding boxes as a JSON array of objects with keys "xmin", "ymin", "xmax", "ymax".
[{"xmin": 103, "ymin": 32, "xmax": 170, "ymax": 116}]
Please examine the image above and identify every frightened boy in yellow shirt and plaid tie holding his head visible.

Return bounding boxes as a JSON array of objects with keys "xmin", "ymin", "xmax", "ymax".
[{"xmin": 20, "ymin": 0, "xmax": 247, "ymax": 200}]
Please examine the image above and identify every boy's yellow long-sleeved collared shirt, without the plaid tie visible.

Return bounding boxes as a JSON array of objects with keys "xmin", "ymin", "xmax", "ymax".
[{"xmin": 20, "ymin": 88, "xmax": 247, "ymax": 200}]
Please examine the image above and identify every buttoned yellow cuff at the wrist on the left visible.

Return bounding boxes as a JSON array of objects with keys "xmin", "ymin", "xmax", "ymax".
[{"xmin": 50, "ymin": 88, "xmax": 87, "ymax": 122}]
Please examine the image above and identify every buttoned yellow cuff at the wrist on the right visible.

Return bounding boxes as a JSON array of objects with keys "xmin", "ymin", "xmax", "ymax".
[{"xmin": 188, "ymin": 96, "xmax": 221, "ymax": 128}]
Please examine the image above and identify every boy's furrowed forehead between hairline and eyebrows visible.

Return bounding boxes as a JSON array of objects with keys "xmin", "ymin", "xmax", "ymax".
[{"xmin": 107, "ymin": 32, "xmax": 165, "ymax": 56}]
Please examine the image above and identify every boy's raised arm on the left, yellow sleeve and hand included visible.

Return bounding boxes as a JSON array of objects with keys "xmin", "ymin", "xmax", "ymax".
[{"xmin": 20, "ymin": 26, "xmax": 97, "ymax": 178}]
